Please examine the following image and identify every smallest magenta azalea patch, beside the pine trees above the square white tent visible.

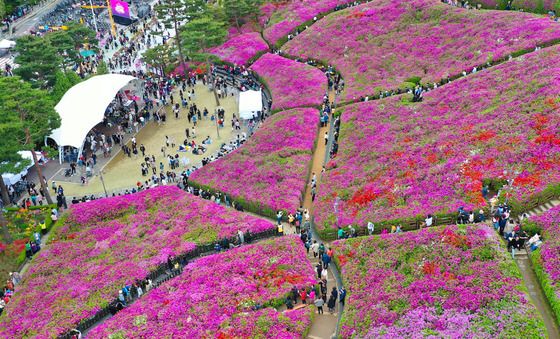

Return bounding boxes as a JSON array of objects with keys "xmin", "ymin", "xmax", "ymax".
[{"xmin": 210, "ymin": 32, "xmax": 268, "ymax": 65}]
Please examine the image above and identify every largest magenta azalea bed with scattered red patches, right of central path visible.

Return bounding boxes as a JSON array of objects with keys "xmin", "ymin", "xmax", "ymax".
[{"xmin": 315, "ymin": 47, "xmax": 560, "ymax": 228}]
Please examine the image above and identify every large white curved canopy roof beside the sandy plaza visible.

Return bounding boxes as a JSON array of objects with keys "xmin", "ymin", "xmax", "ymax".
[{"xmin": 50, "ymin": 74, "xmax": 136, "ymax": 148}]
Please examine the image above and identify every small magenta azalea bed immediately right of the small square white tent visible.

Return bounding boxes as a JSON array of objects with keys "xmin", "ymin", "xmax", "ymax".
[{"xmin": 251, "ymin": 53, "xmax": 327, "ymax": 110}]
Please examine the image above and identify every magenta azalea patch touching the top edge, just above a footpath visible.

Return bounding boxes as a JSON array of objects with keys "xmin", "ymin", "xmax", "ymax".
[{"xmin": 261, "ymin": 0, "xmax": 352, "ymax": 44}]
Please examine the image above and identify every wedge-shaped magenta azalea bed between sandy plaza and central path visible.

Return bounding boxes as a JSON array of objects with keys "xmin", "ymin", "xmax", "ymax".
[{"xmin": 189, "ymin": 108, "xmax": 319, "ymax": 216}]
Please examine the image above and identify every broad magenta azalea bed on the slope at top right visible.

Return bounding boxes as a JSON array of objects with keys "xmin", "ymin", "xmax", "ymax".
[{"xmin": 282, "ymin": 0, "xmax": 560, "ymax": 100}]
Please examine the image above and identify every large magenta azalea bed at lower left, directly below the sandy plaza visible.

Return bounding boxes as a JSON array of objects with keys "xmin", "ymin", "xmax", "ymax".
[{"xmin": 0, "ymin": 186, "xmax": 274, "ymax": 338}]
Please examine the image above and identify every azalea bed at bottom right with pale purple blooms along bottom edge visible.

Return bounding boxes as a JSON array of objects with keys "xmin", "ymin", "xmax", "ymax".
[{"xmin": 333, "ymin": 225, "xmax": 546, "ymax": 338}]
